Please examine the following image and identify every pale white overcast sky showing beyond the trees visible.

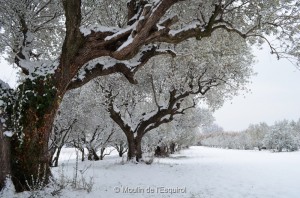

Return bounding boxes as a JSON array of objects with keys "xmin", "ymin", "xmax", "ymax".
[{"xmin": 0, "ymin": 44, "xmax": 300, "ymax": 131}]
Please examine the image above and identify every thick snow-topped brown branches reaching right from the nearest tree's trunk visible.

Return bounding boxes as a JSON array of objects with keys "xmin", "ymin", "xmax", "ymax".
[{"xmin": 63, "ymin": 0, "xmax": 243, "ymax": 89}]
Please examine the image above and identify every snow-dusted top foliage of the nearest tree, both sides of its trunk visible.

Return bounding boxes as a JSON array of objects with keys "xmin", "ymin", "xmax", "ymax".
[{"xmin": 0, "ymin": 0, "xmax": 299, "ymax": 83}]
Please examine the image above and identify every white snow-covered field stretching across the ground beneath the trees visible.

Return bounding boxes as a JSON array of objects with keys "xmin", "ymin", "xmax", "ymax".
[{"xmin": 2, "ymin": 146, "xmax": 300, "ymax": 198}]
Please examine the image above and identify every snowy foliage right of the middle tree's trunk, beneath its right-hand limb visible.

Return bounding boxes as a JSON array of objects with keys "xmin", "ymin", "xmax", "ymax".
[{"xmin": 142, "ymin": 107, "xmax": 214, "ymax": 155}]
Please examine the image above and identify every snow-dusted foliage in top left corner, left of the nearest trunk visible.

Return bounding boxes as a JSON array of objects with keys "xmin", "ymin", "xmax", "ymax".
[{"xmin": 0, "ymin": 0, "xmax": 65, "ymax": 78}]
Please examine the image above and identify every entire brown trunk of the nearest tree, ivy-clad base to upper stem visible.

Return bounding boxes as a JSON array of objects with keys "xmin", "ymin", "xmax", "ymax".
[{"xmin": 6, "ymin": 0, "xmax": 84, "ymax": 192}]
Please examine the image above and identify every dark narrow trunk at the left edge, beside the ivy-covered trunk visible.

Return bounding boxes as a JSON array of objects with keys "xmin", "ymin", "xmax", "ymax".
[{"xmin": 0, "ymin": 117, "xmax": 11, "ymax": 190}]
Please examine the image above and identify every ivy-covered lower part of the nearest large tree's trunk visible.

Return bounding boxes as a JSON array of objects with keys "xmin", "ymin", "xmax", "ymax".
[{"xmin": 11, "ymin": 85, "xmax": 59, "ymax": 192}]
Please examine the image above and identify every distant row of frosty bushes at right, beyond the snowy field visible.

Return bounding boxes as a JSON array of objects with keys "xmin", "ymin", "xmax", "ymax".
[{"xmin": 200, "ymin": 120, "xmax": 300, "ymax": 152}]
